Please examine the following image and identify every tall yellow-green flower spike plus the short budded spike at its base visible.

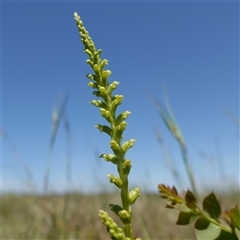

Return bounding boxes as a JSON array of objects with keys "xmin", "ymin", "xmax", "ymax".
[{"xmin": 74, "ymin": 13, "xmax": 140, "ymax": 240}]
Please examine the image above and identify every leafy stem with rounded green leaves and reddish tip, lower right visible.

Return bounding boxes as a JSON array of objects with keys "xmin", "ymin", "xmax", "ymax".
[{"xmin": 158, "ymin": 184, "xmax": 240, "ymax": 240}]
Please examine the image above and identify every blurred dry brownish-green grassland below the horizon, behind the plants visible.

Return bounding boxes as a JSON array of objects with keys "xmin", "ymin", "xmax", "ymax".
[{"xmin": 1, "ymin": 192, "xmax": 239, "ymax": 240}]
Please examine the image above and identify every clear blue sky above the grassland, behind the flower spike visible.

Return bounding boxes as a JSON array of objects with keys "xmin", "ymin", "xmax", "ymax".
[{"xmin": 1, "ymin": 1, "xmax": 240, "ymax": 192}]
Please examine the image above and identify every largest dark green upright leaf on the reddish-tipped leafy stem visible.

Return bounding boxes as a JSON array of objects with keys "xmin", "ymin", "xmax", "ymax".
[{"xmin": 203, "ymin": 193, "xmax": 221, "ymax": 219}]
